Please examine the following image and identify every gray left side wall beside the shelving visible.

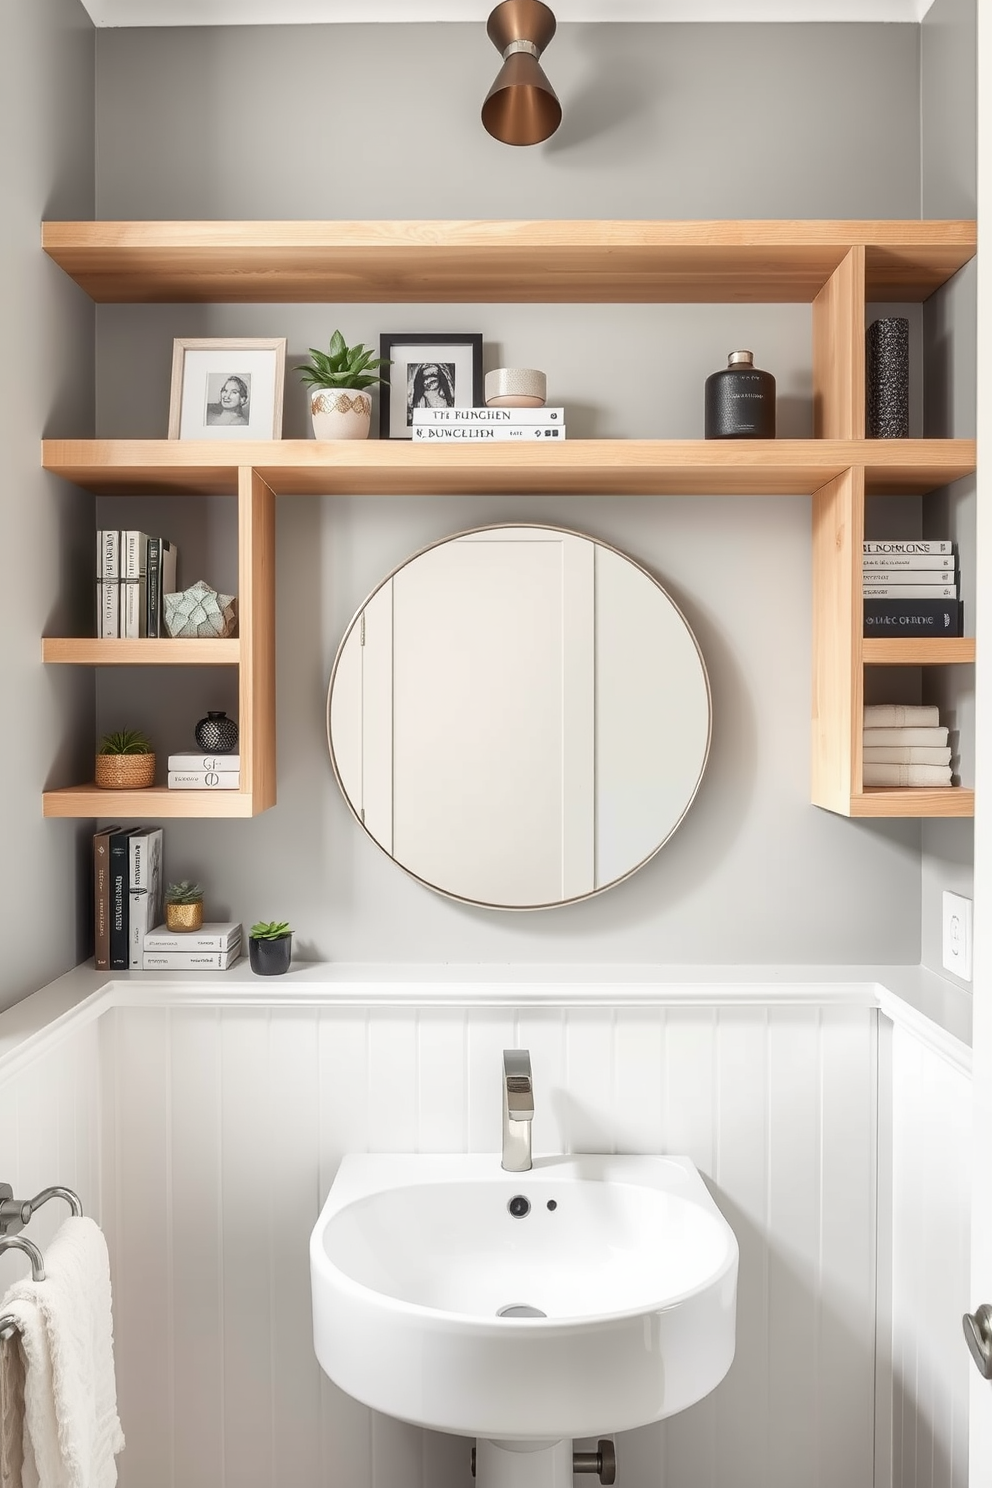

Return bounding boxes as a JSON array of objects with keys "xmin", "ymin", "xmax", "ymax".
[{"xmin": 0, "ymin": 0, "xmax": 94, "ymax": 1007}]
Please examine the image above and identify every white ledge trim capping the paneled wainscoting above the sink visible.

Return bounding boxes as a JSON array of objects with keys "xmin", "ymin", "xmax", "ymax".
[{"xmin": 0, "ymin": 961, "xmax": 971, "ymax": 1079}]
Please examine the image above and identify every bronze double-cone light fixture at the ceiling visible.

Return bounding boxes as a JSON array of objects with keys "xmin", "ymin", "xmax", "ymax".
[{"xmin": 482, "ymin": 0, "xmax": 561, "ymax": 144}]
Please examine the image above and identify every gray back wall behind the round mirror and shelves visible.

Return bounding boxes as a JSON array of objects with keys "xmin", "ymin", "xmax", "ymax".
[{"xmin": 89, "ymin": 25, "xmax": 921, "ymax": 963}]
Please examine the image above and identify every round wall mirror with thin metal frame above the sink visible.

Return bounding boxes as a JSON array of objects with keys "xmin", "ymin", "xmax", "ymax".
[{"xmin": 327, "ymin": 525, "xmax": 711, "ymax": 909}]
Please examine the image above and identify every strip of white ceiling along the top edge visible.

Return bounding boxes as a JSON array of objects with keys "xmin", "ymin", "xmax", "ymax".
[{"xmin": 83, "ymin": 0, "xmax": 933, "ymax": 25}]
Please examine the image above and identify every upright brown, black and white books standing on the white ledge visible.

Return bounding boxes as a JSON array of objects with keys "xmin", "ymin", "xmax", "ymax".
[{"xmin": 92, "ymin": 826, "xmax": 165, "ymax": 972}]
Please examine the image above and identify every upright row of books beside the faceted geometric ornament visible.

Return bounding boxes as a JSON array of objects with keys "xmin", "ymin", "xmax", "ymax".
[{"xmin": 97, "ymin": 528, "xmax": 177, "ymax": 640}]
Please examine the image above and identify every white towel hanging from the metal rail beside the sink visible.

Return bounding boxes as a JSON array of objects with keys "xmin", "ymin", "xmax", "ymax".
[{"xmin": 0, "ymin": 1217, "xmax": 123, "ymax": 1488}]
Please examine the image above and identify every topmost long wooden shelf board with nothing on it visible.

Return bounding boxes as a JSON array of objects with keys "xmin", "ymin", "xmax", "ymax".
[{"xmin": 42, "ymin": 220, "xmax": 976, "ymax": 304}]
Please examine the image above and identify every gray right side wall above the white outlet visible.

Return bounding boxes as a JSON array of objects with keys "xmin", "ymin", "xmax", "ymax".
[{"xmin": 921, "ymin": 0, "xmax": 977, "ymax": 981}]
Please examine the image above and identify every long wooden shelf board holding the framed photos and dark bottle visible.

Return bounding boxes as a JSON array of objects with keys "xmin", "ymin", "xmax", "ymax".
[{"xmin": 42, "ymin": 439, "xmax": 976, "ymax": 496}]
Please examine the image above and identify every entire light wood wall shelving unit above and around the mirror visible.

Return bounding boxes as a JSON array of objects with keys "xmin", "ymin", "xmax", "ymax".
[{"xmin": 42, "ymin": 220, "xmax": 976, "ymax": 818}]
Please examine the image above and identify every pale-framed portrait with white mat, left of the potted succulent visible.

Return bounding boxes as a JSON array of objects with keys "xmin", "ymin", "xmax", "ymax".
[{"xmin": 168, "ymin": 336, "xmax": 286, "ymax": 439}]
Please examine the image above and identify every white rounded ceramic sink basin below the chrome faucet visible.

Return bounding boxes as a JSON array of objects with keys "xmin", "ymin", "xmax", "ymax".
[{"xmin": 309, "ymin": 1153, "xmax": 738, "ymax": 1442}]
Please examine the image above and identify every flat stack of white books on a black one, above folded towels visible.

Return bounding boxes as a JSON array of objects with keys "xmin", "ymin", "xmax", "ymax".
[{"xmin": 861, "ymin": 537, "xmax": 961, "ymax": 635}]
